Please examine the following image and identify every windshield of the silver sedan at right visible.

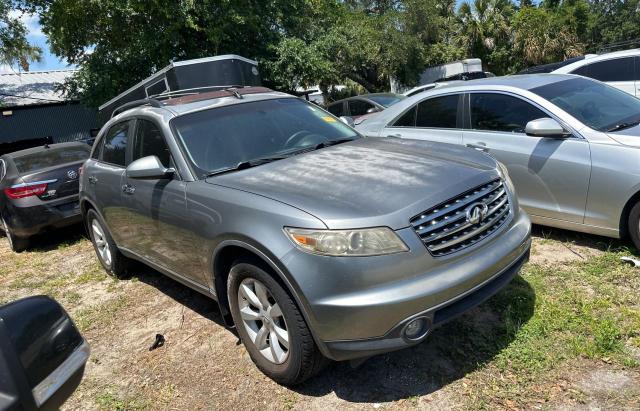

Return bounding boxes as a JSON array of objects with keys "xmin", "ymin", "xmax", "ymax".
[{"xmin": 531, "ymin": 78, "xmax": 640, "ymax": 131}]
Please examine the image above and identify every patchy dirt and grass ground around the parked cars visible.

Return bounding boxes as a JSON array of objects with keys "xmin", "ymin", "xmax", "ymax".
[{"xmin": 0, "ymin": 228, "xmax": 640, "ymax": 410}]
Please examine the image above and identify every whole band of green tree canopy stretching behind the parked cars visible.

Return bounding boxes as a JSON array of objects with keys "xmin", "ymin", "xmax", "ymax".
[{"xmin": 10, "ymin": 0, "xmax": 640, "ymax": 105}]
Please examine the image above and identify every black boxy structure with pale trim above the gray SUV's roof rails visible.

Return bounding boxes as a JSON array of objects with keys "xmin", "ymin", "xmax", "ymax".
[{"xmin": 98, "ymin": 54, "xmax": 262, "ymax": 124}]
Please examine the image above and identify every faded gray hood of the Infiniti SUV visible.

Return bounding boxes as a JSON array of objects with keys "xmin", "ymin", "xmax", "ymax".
[{"xmin": 206, "ymin": 138, "xmax": 498, "ymax": 229}]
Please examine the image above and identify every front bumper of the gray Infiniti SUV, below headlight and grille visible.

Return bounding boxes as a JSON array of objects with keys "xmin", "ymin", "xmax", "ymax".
[{"xmin": 283, "ymin": 210, "xmax": 531, "ymax": 360}]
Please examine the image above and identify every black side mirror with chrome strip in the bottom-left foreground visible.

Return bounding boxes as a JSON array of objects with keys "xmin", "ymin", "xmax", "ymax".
[{"xmin": 0, "ymin": 296, "xmax": 89, "ymax": 410}]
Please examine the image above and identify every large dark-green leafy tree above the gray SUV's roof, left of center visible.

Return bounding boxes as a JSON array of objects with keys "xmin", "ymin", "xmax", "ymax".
[{"xmin": 21, "ymin": 0, "xmax": 330, "ymax": 106}]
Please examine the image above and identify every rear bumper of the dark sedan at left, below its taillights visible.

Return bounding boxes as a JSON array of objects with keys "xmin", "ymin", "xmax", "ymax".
[{"xmin": 5, "ymin": 195, "xmax": 82, "ymax": 238}]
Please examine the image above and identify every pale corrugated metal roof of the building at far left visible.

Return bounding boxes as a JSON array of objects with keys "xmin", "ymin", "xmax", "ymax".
[{"xmin": 0, "ymin": 70, "xmax": 77, "ymax": 107}]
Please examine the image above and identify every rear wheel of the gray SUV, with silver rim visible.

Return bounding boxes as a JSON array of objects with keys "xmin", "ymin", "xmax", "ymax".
[{"xmin": 86, "ymin": 210, "xmax": 131, "ymax": 278}]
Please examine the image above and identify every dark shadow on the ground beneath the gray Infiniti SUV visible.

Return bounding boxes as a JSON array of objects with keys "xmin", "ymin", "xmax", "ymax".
[{"xmin": 125, "ymin": 253, "xmax": 535, "ymax": 403}]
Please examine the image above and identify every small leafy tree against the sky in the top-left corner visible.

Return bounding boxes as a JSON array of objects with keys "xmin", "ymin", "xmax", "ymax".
[{"xmin": 0, "ymin": 0, "xmax": 42, "ymax": 71}]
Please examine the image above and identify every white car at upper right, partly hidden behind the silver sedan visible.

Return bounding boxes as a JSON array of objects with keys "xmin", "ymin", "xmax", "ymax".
[{"xmin": 551, "ymin": 49, "xmax": 640, "ymax": 97}]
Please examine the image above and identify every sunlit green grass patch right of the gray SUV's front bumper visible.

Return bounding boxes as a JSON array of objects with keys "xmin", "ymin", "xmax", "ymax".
[{"xmin": 450, "ymin": 249, "xmax": 640, "ymax": 408}]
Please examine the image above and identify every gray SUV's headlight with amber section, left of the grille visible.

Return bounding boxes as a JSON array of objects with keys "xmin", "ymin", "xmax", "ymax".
[{"xmin": 284, "ymin": 227, "xmax": 409, "ymax": 256}]
